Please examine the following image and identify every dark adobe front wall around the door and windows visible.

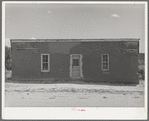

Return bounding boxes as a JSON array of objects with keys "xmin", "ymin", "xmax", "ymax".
[{"xmin": 12, "ymin": 42, "xmax": 138, "ymax": 83}]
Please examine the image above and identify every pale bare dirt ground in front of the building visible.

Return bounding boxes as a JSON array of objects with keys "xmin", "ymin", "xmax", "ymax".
[{"xmin": 5, "ymin": 79, "xmax": 144, "ymax": 107}]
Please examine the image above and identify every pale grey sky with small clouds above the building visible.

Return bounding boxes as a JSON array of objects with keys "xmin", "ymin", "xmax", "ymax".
[{"xmin": 5, "ymin": 3, "xmax": 145, "ymax": 53}]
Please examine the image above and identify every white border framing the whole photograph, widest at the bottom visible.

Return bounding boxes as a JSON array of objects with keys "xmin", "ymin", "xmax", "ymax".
[{"xmin": 2, "ymin": 1, "xmax": 148, "ymax": 120}]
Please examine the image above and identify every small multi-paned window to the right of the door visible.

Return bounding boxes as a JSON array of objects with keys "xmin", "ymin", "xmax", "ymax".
[{"xmin": 102, "ymin": 54, "xmax": 109, "ymax": 70}]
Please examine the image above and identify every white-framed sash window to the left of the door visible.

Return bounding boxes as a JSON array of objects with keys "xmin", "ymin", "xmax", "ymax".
[{"xmin": 41, "ymin": 54, "xmax": 50, "ymax": 72}]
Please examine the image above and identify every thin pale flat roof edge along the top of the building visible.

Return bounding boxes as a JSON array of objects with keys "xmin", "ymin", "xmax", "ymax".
[{"xmin": 10, "ymin": 38, "xmax": 140, "ymax": 42}]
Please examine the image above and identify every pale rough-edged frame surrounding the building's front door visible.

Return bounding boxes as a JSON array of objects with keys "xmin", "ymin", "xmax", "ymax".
[{"xmin": 69, "ymin": 54, "xmax": 83, "ymax": 78}]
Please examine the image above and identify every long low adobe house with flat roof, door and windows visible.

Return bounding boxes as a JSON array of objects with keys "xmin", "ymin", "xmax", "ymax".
[{"xmin": 11, "ymin": 38, "xmax": 139, "ymax": 83}]
